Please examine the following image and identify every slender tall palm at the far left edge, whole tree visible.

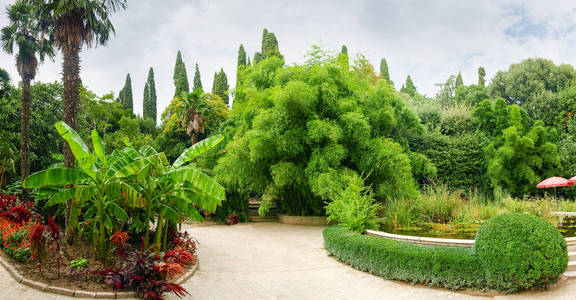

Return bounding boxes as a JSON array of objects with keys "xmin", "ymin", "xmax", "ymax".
[{"xmin": 0, "ymin": 0, "xmax": 54, "ymax": 201}]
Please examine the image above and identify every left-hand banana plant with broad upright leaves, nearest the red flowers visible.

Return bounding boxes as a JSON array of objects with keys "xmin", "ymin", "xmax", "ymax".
[{"xmin": 23, "ymin": 122, "xmax": 139, "ymax": 259}]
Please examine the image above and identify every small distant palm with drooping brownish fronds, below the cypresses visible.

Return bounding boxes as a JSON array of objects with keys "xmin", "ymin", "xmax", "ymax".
[{"xmin": 175, "ymin": 89, "xmax": 210, "ymax": 145}]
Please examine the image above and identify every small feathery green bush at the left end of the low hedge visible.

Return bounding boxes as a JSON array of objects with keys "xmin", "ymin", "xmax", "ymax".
[{"xmin": 326, "ymin": 175, "xmax": 380, "ymax": 233}]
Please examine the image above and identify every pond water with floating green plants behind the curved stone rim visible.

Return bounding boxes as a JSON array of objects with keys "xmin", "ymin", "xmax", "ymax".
[{"xmin": 380, "ymin": 217, "xmax": 576, "ymax": 240}]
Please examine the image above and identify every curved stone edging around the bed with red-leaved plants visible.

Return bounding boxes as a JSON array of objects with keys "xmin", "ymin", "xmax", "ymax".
[{"xmin": 0, "ymin": 251, "xmax": 200, "ymax": 299}]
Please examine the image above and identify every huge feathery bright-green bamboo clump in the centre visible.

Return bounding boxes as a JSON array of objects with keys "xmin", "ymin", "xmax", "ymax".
[{"xmin": 214, "ymin": 51, "xmax": 421, "ymax": 215}]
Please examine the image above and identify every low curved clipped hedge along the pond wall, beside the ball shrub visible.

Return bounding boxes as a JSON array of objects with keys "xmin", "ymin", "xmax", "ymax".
[{"xmin": 323, "ymin": 225, "xmax": 486, "ymax": 289}]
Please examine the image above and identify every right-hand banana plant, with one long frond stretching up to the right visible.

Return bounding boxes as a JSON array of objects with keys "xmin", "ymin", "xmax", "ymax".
[{"xmin": 114, "ymin": 135, "xmax": 225, "ymax": 251}]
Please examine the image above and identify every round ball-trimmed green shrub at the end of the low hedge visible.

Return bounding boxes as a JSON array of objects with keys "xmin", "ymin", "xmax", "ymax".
[{"xmin": 474, "ymin": 213, "xmax": 568, "ymax": 292}]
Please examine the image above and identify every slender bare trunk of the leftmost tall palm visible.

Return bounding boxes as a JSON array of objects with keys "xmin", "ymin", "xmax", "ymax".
[{"xmin": 20, "ymin": 78, "xmax": 30, "ymax": 202}]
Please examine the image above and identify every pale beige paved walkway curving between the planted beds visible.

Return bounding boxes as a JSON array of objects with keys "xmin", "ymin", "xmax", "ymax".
[{"xmin": 0, "ymin": 223, "xmax": 576, "ymax": 300}]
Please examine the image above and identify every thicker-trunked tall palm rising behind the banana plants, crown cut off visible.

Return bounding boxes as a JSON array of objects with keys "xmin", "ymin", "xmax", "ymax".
[{"xmin": 28, "ymin": 0, "xmax": 126, "ymax": 168}]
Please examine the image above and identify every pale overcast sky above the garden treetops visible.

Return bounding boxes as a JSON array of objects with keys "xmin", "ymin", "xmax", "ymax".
[{"xmin": 0, "ymin": 0, "xmax": 576, "ymax": 122}]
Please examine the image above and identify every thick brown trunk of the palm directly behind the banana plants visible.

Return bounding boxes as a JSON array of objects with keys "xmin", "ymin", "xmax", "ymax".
[{"xmin": 62, "ymin": 45, "xmax": 81, "ymax": 242}]
